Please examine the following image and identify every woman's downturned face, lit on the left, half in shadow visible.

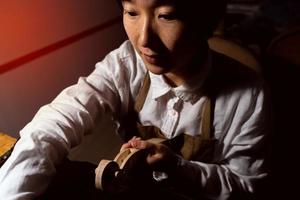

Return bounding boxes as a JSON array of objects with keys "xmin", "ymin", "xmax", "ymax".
[{"xmin": 123, "ymin": 0, "xmax": 201, "ymax": 85}]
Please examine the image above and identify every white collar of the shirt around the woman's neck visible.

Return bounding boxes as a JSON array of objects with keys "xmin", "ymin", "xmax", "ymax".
[{"xmin": 149, "ymin": 50, "xmax": 212, "ymax": 104}]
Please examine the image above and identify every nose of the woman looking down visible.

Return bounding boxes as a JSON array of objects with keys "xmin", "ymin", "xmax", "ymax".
[{"xmin": 139, "ymin": 18, "xmax": 155, "ymax": 47}]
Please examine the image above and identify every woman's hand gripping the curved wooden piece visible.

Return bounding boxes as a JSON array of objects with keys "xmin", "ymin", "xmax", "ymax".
[{"xmin": 121, "ymin": 137, "xmax": 179, "ymax": 172}]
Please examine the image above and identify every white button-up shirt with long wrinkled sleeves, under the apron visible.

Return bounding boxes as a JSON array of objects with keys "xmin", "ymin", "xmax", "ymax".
[{"xmin": 0, "ymin": 41, "xmax": 267, "ymax": 200}]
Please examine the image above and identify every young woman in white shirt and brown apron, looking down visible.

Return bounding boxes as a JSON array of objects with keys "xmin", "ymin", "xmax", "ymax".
[{"xmin": 0, "ymin": 0, "xmax": 268, "ymax": 199}]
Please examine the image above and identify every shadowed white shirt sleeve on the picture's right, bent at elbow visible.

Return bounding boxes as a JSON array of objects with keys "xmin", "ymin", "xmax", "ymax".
[{"xmin": 172, "ymin": 83, "xmax": 269, "ymax": 200}]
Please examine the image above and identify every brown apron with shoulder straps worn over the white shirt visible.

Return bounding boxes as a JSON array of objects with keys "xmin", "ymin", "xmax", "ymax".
[{"xmin": 125, "ymin": 73, "xmax": 215, "ymax": 162}]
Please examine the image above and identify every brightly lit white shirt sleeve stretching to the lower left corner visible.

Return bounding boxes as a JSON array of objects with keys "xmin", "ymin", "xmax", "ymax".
[{"xmin": 0, "ymin": 41, "xmax": 140, "ymax": 200}]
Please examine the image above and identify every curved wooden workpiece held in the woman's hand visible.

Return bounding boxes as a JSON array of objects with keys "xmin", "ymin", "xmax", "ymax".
[{"xmin": 95, "ymin": 138, "xmax": 165, "ymax": 192}]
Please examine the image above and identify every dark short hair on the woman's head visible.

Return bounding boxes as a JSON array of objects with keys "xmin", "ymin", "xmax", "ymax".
[{"xmin": 116, "ymin": 0, "xmax": 227, "ymax": 39}]
